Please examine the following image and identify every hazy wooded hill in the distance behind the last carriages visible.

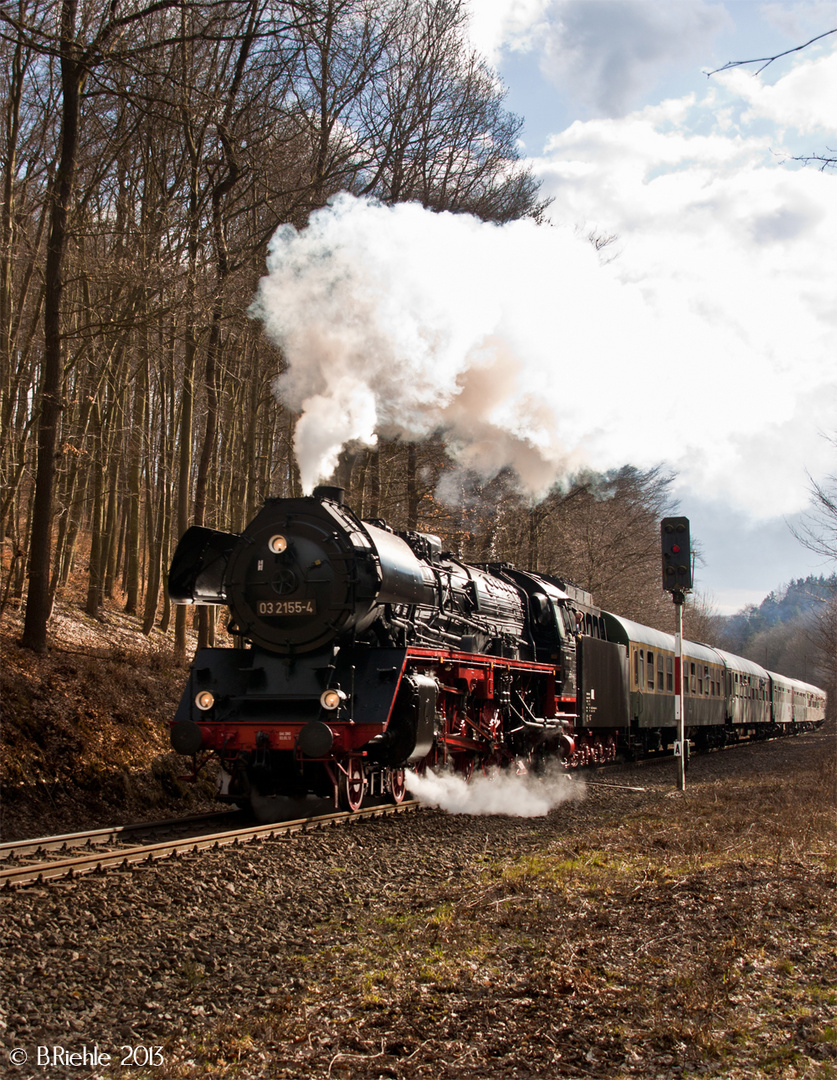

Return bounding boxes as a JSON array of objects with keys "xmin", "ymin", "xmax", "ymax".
[{"xmin": 714, "ymin": 573, "xmax": 837, "ymax": 685}]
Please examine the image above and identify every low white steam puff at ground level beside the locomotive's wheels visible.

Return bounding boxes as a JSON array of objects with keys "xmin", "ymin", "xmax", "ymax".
[{"xmin": 407, "ymin": 770, "xmax": 584, "ymax": 818}]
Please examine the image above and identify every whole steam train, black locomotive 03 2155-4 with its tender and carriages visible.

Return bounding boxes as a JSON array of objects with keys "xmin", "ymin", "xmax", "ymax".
[{"xmin": 168, "ymin": 487, "xmax": 825, "ymax": 816}]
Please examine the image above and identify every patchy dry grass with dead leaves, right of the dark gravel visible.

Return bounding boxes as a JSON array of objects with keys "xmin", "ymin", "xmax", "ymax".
[{"xmin": 152, "ymin": 737, "xmax": 837, "ymax": 1080}]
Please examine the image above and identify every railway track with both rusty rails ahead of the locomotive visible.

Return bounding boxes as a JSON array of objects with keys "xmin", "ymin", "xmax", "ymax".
[{"xmin": 0, "ymin": 799, "xmax": 419, "ymax": 889}]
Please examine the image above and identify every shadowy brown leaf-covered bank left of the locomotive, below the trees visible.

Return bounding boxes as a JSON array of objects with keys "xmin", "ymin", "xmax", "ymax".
[{"xmin": 0, "ymin": 604, "xmax": 221, "ymax": 840}]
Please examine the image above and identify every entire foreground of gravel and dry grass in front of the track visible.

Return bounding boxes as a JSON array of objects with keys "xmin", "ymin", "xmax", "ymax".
[{"xmin": 0, "ymin": 731, "xmax": 837, "ymax": 1080}]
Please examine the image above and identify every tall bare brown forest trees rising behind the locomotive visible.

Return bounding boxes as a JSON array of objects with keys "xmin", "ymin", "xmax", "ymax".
[{"xmin": 0, "ymin": 0, "xmax": 837, "ymax": 699}]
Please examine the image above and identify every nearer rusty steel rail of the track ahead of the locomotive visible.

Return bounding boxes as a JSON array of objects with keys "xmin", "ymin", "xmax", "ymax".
[{"xmin": 0, "ymin": 799, "xmax": 419, "ymax": 889}]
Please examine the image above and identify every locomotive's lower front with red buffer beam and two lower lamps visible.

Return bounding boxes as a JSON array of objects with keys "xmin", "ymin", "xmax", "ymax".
[{"xmin": 172, "ymin": 647, "xmax": 437, "ymax": 815}]
